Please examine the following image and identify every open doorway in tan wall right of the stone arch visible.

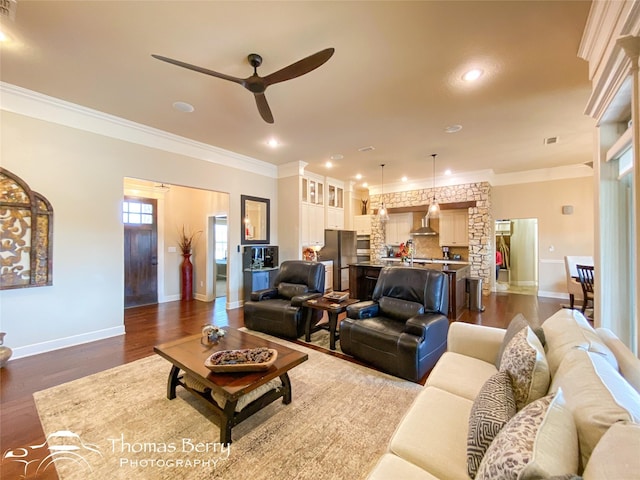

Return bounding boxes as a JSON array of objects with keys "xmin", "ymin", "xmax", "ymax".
[{"xmin": 495, "ymin": 218, "xmax": 538, "ymax": 295}]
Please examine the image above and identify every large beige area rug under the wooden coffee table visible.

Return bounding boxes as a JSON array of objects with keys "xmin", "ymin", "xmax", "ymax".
[{"xmin": 33, "ymin": 337, "xmax": 422, "ymax": 480}]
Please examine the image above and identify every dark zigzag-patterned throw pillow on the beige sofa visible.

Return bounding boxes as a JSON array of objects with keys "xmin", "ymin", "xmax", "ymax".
[{"xmin": 467, "ymin": 372, "xmax": 516, "ymax": 478}]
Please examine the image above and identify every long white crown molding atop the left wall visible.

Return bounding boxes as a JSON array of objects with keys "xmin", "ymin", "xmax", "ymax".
[{"xmin": 0, "ymin": 82, "xmax": 278, "ymax": 178}]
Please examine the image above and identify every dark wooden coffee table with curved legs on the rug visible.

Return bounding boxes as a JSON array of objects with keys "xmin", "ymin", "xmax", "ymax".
[{"xmin": 153, "ymin": 329, "xmax": 308, "ymax": 444}]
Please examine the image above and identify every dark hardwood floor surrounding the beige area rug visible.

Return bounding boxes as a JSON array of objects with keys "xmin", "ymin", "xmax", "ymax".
[{"xmin": 0, "ymin": 293, "xmax": 561, "ymax": 480}]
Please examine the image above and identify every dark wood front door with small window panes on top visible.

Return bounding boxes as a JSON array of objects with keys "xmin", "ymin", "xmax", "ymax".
[{"xmin": 122, "ymin": 197, "xmax": 158, "ymax": 308}]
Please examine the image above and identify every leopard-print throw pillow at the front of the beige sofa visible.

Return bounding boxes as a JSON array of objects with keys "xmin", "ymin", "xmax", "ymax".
[{"xmin": 476, "ymin": 390, "xmax": 579, "ymax": 480}]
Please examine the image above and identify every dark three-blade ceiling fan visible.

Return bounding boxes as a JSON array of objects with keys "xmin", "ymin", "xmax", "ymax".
[{"xmin": 151, "ymin": 48, "xmax": 335, "ymax": 123}]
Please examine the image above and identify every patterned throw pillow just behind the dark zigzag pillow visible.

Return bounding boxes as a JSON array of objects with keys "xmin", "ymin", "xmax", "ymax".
[{"xmin": 500, "ymin": 327, "xmax": 551, "ymax": 410}]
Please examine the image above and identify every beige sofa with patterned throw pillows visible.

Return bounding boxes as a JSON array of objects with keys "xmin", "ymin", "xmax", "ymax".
[{"xmin": 368, "ymin": 309, "xmax": 640, "ymax": 480}]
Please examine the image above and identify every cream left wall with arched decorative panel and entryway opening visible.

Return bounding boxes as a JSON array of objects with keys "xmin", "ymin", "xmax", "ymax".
[{"xmin": 0, "ymin": 104, "xmax": 278, "ymax": 358}]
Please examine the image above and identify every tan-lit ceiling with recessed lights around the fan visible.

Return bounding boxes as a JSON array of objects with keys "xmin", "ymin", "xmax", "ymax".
[{"xmin": 0, "ymin": 0, "xmax": 594, "ymax": 188}]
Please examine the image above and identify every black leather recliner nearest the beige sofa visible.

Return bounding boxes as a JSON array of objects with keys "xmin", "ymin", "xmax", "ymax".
[{"xmin": 340, "ymin": 267, "xmax": 449, "ymax": 382}]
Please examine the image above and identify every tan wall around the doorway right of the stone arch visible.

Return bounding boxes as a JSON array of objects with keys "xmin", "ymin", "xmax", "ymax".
[{"xmin": 491, "ymin": 177, "xmax": 594, "ymax": 296}]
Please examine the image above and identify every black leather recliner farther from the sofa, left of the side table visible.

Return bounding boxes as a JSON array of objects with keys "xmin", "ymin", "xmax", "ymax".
[{"xmin": 244, "ymin": 260, "xmax": 324, "ymax": 338}]
